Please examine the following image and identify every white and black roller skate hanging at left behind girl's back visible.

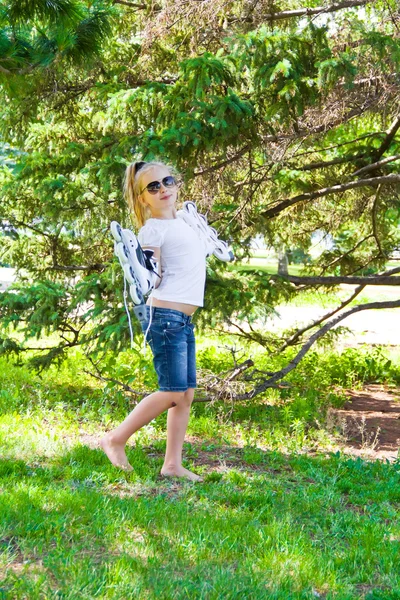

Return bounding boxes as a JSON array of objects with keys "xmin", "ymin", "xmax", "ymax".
[{"xmin": 110, "ymin": 221, "xmax": 159, "ymax": 305}]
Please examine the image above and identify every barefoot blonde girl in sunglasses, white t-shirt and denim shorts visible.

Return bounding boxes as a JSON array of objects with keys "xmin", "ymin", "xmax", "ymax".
[{"xmin": 100, "ymin": 162, "xmax": 206, "ymax": 481}]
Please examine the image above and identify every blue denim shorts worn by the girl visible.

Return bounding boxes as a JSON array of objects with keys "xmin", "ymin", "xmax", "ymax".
[{"xmin": 140, "ymin": 306, "xmax": 196, "ymax": 392}]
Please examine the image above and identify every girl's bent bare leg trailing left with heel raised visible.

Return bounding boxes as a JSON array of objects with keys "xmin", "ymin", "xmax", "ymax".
[{"xmin": 100, "ymin": 392, "xmax": 186, "ymax": 471}]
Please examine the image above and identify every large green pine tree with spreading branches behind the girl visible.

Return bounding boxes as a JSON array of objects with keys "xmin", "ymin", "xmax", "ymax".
[{"xmin": 0, "ymin": 0, "xmax": 400, "ymax": 394}]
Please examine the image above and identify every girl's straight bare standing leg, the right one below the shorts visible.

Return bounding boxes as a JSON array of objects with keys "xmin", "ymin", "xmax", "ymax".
[{"xmin": 161, "ymin": 388, "xmax": 201, "ymax": 481}]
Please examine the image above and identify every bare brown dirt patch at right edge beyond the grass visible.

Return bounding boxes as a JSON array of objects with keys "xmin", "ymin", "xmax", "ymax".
[{"xmin": 330, "ymin": 384, "xmax": 400, "ymax": 461}]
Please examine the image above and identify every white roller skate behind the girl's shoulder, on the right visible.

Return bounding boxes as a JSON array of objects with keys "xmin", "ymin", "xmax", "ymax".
[{"xmin": 177, "ymin": 200, "xmax": 235, "ymax": 262}]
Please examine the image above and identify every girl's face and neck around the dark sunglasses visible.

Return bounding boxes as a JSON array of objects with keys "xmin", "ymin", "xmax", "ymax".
[{"xmin": 138, "ymin": 167, "xmax": 178, "ymax": 218}]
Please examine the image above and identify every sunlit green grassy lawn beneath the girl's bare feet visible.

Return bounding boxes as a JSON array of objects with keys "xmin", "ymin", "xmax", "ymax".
[{"xmin": 0, "ymin": 345, "xmax": 400, "ymax": 600}]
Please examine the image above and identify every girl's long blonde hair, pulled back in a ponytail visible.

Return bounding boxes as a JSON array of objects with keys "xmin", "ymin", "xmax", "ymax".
[{"xmin": 123, "ymin": 161, "xmax": 177, "ymax": 228}]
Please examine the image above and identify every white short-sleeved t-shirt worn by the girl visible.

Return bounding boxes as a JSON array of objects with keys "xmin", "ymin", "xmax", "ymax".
[{"xmin": 138, "ymin": 217, "xmax": 207, "ymax": 306}]
